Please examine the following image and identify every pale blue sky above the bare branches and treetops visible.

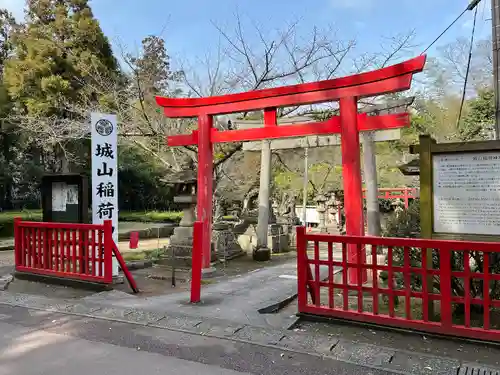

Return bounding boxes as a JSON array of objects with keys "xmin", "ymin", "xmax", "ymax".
[{"xmin": 0, "ymin": 0, "xmax": 491, "ymax": 67}]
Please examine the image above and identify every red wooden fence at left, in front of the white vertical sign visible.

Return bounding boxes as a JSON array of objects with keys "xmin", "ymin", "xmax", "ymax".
[{"xmin": 14, "ymin": 219, "xmax": 113, "ymax": 284}]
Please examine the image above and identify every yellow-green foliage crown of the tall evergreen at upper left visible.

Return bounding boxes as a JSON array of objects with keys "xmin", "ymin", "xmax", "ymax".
[{"xmin": 4, "ymin": 0, "xmax": 118, "ymax": 116}]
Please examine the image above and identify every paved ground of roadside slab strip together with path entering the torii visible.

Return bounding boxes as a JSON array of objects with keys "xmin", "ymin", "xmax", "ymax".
[{"xmin": 0, "ymin": 242, "xmax": 500, "ymax": 375}]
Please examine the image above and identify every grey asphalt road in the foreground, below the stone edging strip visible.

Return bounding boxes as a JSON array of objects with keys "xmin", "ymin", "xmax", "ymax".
[{"xmin": 0, "ymin": 305, "xmax": 432, "ymax": 375}]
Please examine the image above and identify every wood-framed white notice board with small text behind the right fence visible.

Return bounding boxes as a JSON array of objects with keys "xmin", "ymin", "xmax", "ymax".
[{"xmin": 419, "ymin": 136, "xmax": 500, "ymax": 241}]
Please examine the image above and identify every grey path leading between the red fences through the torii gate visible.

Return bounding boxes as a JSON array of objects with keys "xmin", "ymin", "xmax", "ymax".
[{"xmin": 84, "ymin": 262, "xmax": 328, "ymax": 329}]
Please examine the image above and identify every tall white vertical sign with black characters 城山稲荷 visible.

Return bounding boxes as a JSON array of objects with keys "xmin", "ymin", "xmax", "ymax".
[{"xmin": 91, "ymin": 113, "xmax": 118, "ymax": 276}]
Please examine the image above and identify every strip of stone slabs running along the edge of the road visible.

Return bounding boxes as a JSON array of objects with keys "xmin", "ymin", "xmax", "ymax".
[{"xmin": 0, "ymin": 292, "xmax": 496, "ymax": 375}]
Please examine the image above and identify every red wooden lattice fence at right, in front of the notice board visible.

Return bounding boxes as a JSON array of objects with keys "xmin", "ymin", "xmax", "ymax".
[{"xmin": 297, "ymin": 227, "xmax": 500, "ymax": 341}]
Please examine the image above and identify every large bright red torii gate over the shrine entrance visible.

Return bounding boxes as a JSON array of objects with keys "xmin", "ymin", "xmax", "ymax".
[{"xmin": 156, "ymin": 55, "xmax": 426, "ymax": 296}]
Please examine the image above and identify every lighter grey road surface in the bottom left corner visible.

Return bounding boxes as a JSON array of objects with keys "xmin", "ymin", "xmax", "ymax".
[{"xmin": 0, "ymin": 323, "xmax": 248, "ymax": 375}]
